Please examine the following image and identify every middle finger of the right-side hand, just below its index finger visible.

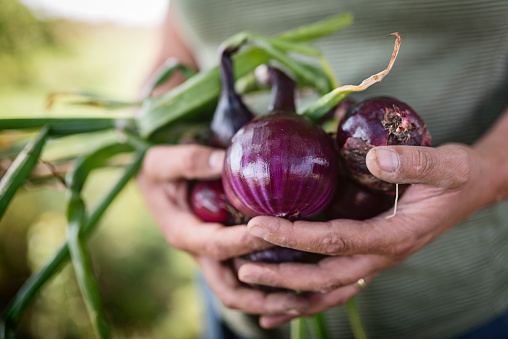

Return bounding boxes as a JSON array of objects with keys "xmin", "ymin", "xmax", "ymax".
[{"xmin": 238, "ymin": 255, "xmax": 384, "ymax": 293}]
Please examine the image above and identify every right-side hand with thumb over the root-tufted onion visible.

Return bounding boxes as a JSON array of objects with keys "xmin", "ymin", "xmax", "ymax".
[{"xmin": 239, "ymin": 144, "xmax": 488, "ymax": 328}]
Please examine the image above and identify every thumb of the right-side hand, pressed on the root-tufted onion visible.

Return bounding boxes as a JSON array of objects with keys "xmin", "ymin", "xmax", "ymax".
[{"xmin": 366, "ymin": 144, "xmax": 470, "ymax": 188}]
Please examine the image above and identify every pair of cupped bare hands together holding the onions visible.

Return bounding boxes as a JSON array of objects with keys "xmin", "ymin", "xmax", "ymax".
[{"xmin": 138, "ymin": 103, "xmax": 508, "ymax": 328}]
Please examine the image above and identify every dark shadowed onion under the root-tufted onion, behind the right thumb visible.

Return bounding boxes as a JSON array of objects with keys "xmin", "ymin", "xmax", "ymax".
[{"xmin": 324, "ymin": 177, "xmax": 395, "ymax": 220}]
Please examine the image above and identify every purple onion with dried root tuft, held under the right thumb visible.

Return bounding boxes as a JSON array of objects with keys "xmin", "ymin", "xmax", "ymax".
[{"xmin": 336, "ymin": 97, "xmax": 431, "ymax": 192}]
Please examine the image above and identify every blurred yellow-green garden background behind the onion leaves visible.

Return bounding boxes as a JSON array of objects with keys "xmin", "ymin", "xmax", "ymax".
[{"xmin": 0, "ymin": 0, "xmax": 201, "ymax": 339}]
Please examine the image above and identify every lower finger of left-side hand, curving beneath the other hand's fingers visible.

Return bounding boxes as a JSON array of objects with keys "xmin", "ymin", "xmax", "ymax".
[{"xmin": 196, "ymin": 257, "xmax": 308, "ymax": 316}]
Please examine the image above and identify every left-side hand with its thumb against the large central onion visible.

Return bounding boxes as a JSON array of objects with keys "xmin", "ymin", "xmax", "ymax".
[{"xmin": 138, "ymin": 145, "xmax": 308, "ymax": 316}]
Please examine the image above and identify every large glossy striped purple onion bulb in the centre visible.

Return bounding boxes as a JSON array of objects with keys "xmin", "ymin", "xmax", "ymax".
[{"xmin": 222, "ymin": 113, "xmax": 338, "ymax": 220}]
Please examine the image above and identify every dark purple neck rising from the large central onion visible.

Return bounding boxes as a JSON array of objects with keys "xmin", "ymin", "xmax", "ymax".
[{"xmin": 268, "ymin": 67, "xmax": 296, "ymax": 114}]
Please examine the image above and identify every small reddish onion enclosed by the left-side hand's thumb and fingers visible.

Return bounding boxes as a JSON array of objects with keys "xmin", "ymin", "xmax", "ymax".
[{"xmin": 190, "ymin": 179, "xmax": 234, "ymax": 225}]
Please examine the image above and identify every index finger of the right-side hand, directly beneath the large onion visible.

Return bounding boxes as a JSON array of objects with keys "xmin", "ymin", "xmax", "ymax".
[{"xmin": 247, "ymin": 213, "xmax": 418, "ymax": 256}]
